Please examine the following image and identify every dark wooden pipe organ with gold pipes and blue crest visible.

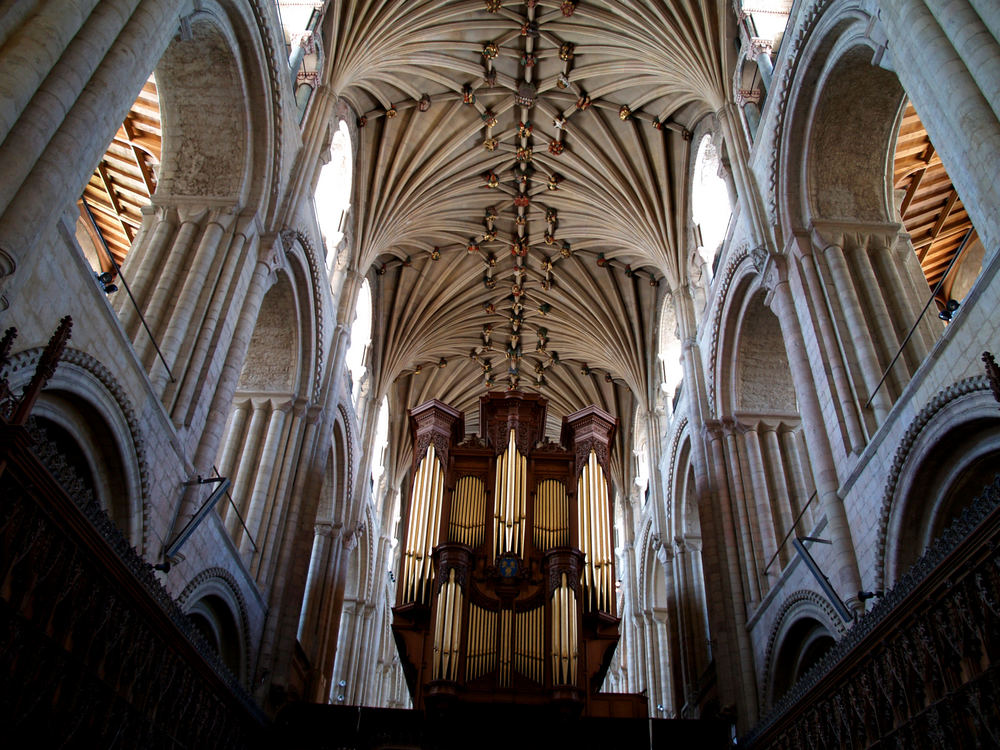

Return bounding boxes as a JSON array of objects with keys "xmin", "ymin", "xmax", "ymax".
[{"xmin": 392, "ymin": 392, "xmax": 648, "ymax": 718}]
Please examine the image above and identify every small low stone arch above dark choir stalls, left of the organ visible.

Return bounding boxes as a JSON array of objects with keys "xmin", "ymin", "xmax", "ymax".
[{"xmin": 177, "ymin": 568, "xmax": 250, "ymax": 685}]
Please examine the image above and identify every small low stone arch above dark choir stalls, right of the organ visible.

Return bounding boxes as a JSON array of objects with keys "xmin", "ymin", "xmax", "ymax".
[{"xmin": 760, "ymin": 589, "xmax": 846, "ymax": 713}]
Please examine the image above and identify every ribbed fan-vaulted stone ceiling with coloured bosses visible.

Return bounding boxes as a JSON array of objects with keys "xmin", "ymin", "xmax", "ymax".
[{"xmin": 324, "ymin": 0, "xmax": 734, "ymax": 484}]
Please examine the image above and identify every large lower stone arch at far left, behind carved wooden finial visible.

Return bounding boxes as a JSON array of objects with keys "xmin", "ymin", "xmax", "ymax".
[{"xmin": 1, "ymin": 348, "xmax": 149, "ymax": 552}]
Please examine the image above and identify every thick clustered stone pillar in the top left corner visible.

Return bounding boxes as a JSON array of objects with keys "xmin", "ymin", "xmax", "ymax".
[{"xmin": 0, "ymin": 0, "xmax": 181, "ymax": 290}]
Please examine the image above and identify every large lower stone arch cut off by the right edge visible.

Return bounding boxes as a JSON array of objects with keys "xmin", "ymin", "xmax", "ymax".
[{"xmin": 877, "ymin": 375, "xmax": 1000, "ymax": 588}]
